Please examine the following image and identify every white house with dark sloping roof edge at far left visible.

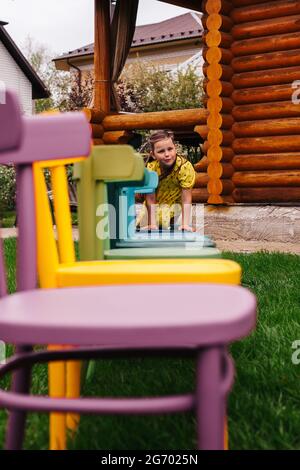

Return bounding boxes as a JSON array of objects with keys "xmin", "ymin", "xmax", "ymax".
[{"xmin": 0, "ymin": 21, "xmax": 49, "ymax": 115}]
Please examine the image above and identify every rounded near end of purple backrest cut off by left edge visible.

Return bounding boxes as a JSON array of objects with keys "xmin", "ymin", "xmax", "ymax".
[{"xmin": 0, "ymin": 90, "xmax": 23, "ymax": 154}]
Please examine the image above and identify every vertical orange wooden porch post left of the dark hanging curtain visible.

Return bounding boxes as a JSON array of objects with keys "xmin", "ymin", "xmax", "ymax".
[{"xmin": 94, "ymin": 0, "xmax": 110, "ymax": 113}]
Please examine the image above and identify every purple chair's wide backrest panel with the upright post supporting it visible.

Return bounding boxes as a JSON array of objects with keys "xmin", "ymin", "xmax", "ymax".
[{"xmin": 0, "ymin": 92, "xmax": 91, "ymax": 296}]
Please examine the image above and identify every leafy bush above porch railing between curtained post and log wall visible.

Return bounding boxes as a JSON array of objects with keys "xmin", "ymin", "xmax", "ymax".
[{"xmin": 117, "ymin": 61, "xmax": 203, "ymax": 112}]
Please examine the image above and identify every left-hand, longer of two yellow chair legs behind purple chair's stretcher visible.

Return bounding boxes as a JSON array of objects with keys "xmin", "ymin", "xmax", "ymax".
[{"xmin": 48, "ymin": 346, "xmax": 66, "ymax": 450}]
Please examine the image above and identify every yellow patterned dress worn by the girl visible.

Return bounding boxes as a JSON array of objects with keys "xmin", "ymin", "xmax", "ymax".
[{"xmin": 137, "ymin": 156, "xmax": 196, "ymax": 228}]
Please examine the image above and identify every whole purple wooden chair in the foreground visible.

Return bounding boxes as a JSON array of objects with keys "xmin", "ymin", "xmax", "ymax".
[{"xmin": 0, "ymin": 91, "xmax": 256, "ymax": 449}]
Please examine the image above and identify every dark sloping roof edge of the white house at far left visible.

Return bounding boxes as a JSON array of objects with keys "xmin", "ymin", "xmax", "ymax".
[{"xmin": 0, "ymin": 21, "xmax": 49, "ymax": 100}]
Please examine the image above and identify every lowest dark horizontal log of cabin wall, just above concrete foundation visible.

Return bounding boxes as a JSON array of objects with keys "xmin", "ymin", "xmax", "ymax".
[{"xmin": 232, "ymin": 186, "xmax": 300, "ymax": 203}]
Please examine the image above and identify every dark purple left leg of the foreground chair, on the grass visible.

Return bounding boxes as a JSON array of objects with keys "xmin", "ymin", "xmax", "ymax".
[{"xmin": 5, "ymin": 347, "xmax": 32, "ymax": 450}]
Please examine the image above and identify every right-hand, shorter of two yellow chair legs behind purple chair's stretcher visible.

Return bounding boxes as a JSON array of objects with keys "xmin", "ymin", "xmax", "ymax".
[{"xmin": 66, "ymin": 361, "xmax": 81, "ymax": 435}]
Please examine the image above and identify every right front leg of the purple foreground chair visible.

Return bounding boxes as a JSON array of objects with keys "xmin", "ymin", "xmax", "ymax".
[{"xmin": 196, "ymin": 347, "xmax": 225, "ymax": 450}]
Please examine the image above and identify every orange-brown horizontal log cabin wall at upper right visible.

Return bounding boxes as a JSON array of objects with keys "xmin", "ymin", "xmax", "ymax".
[{"xmin": 230, "ymin": 0, "xmax": 300, "ymax": 203}]
